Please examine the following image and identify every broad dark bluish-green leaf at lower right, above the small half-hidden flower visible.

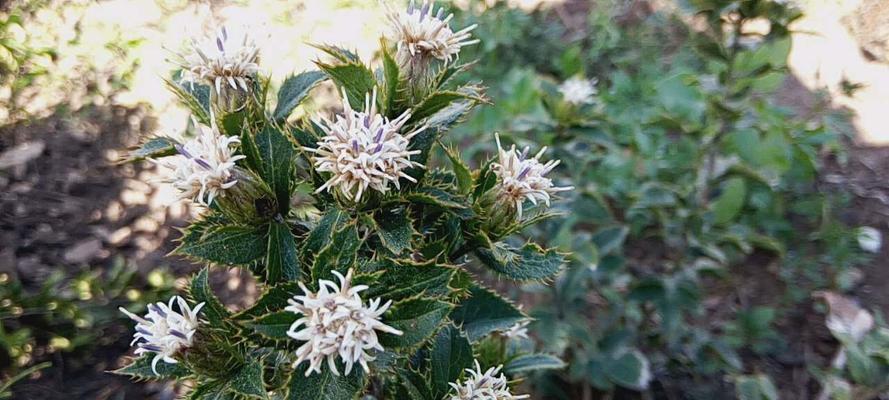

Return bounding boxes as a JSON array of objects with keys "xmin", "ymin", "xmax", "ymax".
[{"xmin": 451, "ymin": 286, "xmax": 527, "ymax": 342}]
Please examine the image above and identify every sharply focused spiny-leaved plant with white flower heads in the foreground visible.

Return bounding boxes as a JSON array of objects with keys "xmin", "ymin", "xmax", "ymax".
[{"xmin": 117, "ymin": 2, "xmax": 571, "ymax": 400}]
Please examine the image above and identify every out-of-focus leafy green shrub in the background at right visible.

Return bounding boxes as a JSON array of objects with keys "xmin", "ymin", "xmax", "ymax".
[{"xmin": 450, "ymin": 0, "xmax": 885, "ymax": 399}]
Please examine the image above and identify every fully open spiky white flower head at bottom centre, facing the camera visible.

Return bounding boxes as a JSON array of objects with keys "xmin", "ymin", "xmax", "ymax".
[{"xmin": 285, "ymin": 269, "xmax": 402, "ymax": 376}]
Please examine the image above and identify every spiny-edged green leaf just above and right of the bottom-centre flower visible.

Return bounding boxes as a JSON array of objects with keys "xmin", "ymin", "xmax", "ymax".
[{"xmin": 364, "ymin": 261, "xmax": 454, "ymax": 301}]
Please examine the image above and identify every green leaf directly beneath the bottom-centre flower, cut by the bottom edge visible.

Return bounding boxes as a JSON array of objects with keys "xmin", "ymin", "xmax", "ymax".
[{"xmin": 287, "ymin": 363, "xmax": 365, "ymax": 400}]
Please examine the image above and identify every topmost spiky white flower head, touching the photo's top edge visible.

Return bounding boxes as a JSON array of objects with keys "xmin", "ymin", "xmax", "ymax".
[{"xmin": 383, "ymin": 0, "xmax": 479, "ymax": 62}]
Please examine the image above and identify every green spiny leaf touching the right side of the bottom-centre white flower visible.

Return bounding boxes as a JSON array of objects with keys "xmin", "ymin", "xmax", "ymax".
[{"xmin": 380, "ymin": 298, "xmax": 453, "ymax": 348}]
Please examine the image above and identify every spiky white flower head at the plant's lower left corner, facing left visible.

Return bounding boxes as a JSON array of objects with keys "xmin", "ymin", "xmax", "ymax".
[{"xmin": 120, "ymin": 296, "xmax": 204, "ymax": 374}]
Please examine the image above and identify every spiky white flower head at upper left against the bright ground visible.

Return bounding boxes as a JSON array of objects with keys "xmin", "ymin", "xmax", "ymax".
[{"xmin": 176, "ymin": 26, "xmax": 259, "ymax": 94}]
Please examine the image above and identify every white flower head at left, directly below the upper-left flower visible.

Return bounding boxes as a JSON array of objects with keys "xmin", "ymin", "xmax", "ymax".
[{"xmin": 155, "ymin": 117, "xmax": 245, "ymax": 206}]
